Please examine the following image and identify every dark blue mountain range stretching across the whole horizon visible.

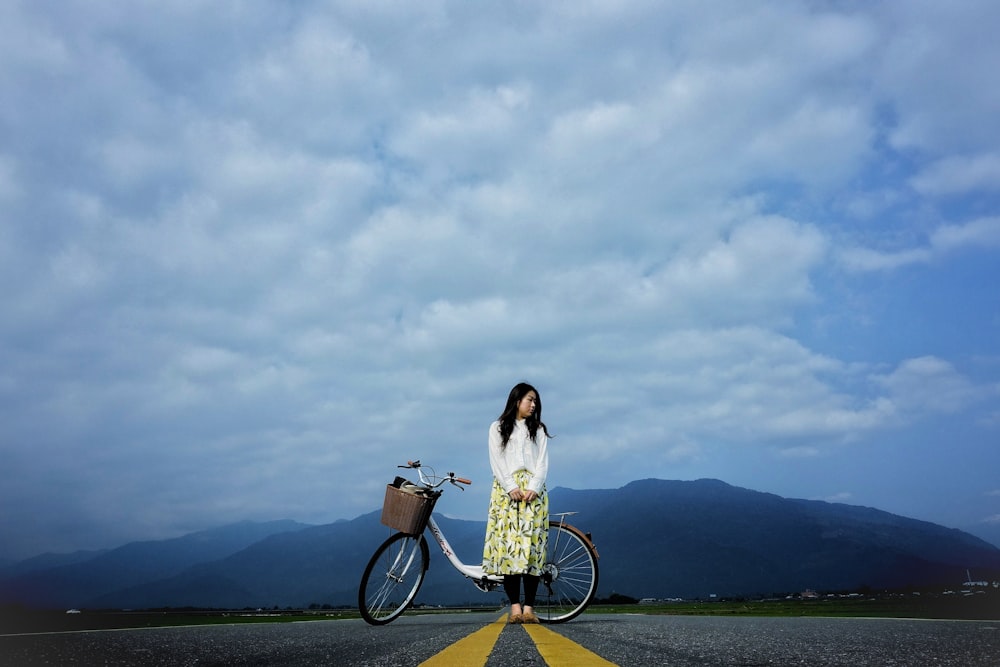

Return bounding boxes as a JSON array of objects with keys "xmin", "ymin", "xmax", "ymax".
[{"xmin": 0, "ymin": 479, "xmax": 1000, "ymax": 608}]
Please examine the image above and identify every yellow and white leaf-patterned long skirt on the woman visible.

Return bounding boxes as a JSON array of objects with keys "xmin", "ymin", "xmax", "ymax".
[{"xmin": 483, "ymin": 470, "xmax": 549, "ymax": 576}]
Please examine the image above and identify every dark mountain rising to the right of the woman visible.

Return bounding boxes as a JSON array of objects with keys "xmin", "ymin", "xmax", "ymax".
[{"xmin": 551, "ymin": 479, "xmax": 1000, "ymax": 598}]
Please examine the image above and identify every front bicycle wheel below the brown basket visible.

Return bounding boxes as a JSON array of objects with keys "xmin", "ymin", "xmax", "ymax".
[{"xmin": 358, "ymin": 533, "xmax": 430, "ymax": 625}]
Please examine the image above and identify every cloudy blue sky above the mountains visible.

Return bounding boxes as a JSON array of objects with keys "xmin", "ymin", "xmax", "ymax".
[{"xmin": 0, "ymin": 0, "xmax": 1000, "ymax": 559}]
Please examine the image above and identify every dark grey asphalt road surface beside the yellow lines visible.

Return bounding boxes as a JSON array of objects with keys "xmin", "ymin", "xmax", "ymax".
[{"xmin": 0, "ymin": 612, "xmax": 1000, "ymax": 667}]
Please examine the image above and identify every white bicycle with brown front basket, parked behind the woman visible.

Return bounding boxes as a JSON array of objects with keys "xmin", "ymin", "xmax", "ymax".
[{"xmin": 358, "ymin": 461, "xmax": 599, "ymax": 625}]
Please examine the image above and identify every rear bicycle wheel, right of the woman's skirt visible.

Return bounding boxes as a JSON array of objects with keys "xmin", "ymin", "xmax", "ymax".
[{"xmin": 535, "ymin": 521, "xmax": 598, "ymax": 623}]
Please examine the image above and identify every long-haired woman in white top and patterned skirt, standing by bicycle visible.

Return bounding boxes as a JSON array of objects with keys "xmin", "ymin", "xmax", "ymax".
[{"xmin": 483, "ymin": 382, "xmax": 549, "ymax": 623}]
